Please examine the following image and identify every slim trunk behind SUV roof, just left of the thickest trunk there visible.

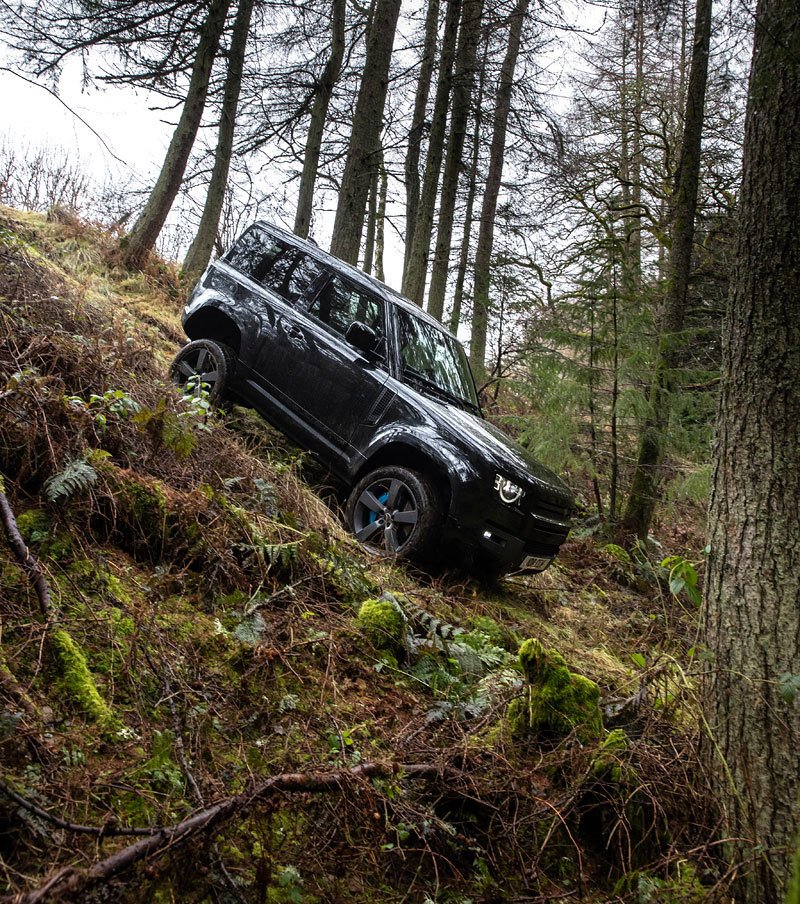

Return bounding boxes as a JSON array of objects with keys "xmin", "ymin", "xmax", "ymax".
[{"xmin": 294, "ymin": 0, "xmax": 345, "ymax": 239}]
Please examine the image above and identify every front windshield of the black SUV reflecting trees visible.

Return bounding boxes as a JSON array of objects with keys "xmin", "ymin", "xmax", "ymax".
[{"xmin": 396, "ymin": 307, "xmax": 480, "ymax": 410}]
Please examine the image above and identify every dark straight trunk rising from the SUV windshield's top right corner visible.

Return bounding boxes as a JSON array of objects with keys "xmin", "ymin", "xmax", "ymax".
[{"xmin": 428, "ymin": 0, "xmax": 483, "ymax": 320}]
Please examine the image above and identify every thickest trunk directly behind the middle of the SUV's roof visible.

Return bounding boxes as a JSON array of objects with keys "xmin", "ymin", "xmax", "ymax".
[{"xmin": 331, "ymin": 0, "xmax": 401, "ymax": 264}]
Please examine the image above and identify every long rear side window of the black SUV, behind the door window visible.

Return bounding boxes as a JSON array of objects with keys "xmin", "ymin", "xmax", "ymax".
[{"xmin": 227, "ymin": 226, "xmax": 322, "ymax": 304}]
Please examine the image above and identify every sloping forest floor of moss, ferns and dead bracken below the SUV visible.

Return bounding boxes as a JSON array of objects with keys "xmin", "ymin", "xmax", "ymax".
[{"xmin": 0, "ymin": 208, "xmax": 727, "ymax": 904}]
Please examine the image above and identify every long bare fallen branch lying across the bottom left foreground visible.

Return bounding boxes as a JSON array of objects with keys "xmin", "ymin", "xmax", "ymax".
[{"xmin": 9, "ymin": 763, "xmax": 462, "ymax": 904}]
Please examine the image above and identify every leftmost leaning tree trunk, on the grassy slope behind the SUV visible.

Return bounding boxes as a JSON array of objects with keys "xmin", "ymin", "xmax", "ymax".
[{"xmin": 123, "ymin": 0, "xmax": 231, "ymax": 267}]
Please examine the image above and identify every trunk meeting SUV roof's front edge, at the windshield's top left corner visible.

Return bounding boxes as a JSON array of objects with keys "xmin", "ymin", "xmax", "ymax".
[{"xmin": 403, "ymin": 0, "xmax": 461, "ymax": 305}]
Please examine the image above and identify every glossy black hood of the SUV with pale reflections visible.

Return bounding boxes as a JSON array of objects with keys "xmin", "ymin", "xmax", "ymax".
[{"xmin": 425, "ymin": 396, "xmax": 572, "ymax": 505}]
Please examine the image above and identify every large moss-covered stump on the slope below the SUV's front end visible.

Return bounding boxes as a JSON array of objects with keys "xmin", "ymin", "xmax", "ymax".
[{"xmin": 508, "ymin": 638, "xmax": 603, "ymax": 741}]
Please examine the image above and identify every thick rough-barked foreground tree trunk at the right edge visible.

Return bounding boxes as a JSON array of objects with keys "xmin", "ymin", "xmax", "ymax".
[{"xmin": 705, "ymin": 0, "xmax": 800, "ymax": 904}]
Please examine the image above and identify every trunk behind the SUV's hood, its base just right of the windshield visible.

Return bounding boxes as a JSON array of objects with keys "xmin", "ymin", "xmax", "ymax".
[{"xmin": 469, "ymin": 0, "xmax": 530, "ymax": 383}]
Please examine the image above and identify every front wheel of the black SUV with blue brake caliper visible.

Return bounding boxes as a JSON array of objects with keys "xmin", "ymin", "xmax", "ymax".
[{"xmin": 345, "ymin": 465, "xmax": 442, "ymax": 561}]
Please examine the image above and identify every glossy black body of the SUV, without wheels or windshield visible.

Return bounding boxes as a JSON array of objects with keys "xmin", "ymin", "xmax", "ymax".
[{"xmin": 183, "ymin": 223, "xmax": 572, "ymax": 571}]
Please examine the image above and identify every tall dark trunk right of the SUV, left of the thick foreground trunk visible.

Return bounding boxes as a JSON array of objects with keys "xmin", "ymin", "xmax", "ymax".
[{"xmin": 620, "ymin": 0, "xmax": 711, "ymax": 539}]
